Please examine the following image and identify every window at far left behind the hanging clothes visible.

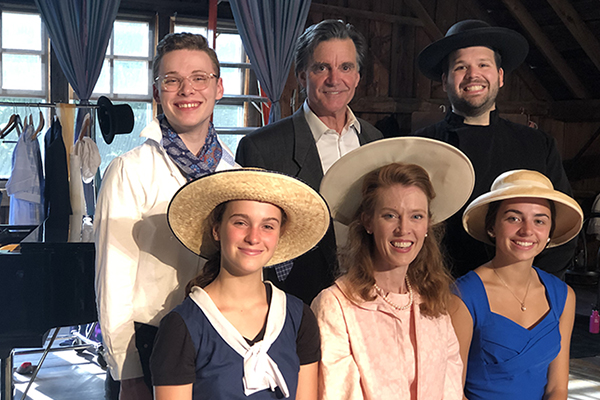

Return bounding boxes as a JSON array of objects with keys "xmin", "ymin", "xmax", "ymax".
[{"xmin": 0, "ymin": 11, "xmax": 49, "ymax": 179}]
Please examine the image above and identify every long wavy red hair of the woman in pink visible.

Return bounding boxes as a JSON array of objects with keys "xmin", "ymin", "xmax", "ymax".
[{"xmin": 340, "ymin": 163, "xmax": 453, "ymax": 317}]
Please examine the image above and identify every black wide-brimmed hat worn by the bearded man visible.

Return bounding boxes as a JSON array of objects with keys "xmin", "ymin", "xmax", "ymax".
[{"xmin": 417, "ymin": 19, "xmax": 529, "ymax": 81}]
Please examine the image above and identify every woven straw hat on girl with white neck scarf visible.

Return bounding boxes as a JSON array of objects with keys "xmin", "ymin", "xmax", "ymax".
[{"xmin": 167, "ymin": 169, "xmax": 329, "ymax": 265}]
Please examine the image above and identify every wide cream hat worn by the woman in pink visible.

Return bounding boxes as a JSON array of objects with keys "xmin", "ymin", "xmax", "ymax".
[{"xmin": 320, "ymin": 137, "xmax": 475, "ymax": 225}]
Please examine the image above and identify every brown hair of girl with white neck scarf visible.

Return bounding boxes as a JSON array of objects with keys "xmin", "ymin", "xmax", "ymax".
[{"xmin": 185, "ymin": 200, "xmax": 287, "ymax": 295}]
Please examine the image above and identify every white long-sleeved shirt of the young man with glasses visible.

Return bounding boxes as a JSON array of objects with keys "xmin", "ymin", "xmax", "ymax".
[{"xmin": 94, "ymin": 118, "xmax": 238, "ymax": 380}]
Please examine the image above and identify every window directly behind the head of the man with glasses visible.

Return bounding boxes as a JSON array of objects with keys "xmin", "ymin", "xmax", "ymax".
[{"xmin": 173, "ymin": 20, "xmax": 260, "ymax": 154}]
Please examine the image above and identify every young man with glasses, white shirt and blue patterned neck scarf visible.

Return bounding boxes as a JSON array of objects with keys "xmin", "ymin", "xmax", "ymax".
[{"xmin": 95, "ymin": 33, "xmax": 236, "ymax": 400}]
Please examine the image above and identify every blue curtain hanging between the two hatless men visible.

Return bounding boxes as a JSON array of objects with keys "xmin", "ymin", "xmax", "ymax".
[{"xmin": 229, "ymin": 0, "xmax": 311, "ymax": 123}]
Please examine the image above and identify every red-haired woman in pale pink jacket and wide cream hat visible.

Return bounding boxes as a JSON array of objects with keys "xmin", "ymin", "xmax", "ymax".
[{"xmin": 312, "ymin": 138, "xmax": 474, "ymax": 400}]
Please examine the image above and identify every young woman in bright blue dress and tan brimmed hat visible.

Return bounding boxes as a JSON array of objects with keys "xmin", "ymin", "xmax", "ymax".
[{"xmin": 451, "ymin": 170, "xmax": 583, "ymax": 400}]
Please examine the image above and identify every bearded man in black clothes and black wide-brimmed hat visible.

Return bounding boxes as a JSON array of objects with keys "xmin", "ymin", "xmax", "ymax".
[{"xmin": 415, "ymin": 20, "xmax": 576, "ymax": 277}]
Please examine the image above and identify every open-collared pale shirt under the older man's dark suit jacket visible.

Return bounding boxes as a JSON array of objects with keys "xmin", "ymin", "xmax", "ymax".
[{"xmin": 303, "ymin": 101, "xmax": 360, "ymax": 174}]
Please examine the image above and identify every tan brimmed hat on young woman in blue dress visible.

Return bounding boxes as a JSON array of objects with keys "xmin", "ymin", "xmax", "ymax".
[{"xmin": 463, "ymin": 169, "xmax": 583, "ymax": 247}]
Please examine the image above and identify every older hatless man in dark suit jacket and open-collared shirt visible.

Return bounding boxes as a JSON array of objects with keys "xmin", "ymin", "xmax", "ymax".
[{"xmin": 236, "ymin": 20, "xmax": 382, "ymax": 303}]
